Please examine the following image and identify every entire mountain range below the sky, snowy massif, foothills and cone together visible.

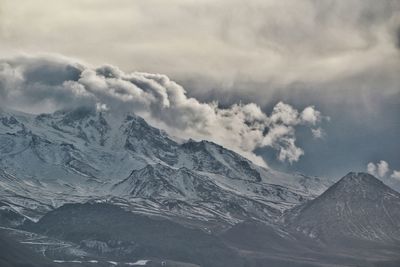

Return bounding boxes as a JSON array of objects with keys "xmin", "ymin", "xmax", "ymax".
[{"xmin": 0, "ymin": 108, "xmax": 400, "ymax": 267}]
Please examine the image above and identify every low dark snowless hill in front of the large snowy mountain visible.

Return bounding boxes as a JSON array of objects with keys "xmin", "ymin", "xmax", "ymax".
[{"xmin": 24, "ymin": 203, "xmax": 243, "ymax": 267}]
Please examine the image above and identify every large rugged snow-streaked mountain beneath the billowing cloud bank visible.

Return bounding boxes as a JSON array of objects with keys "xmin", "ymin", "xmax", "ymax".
[{"xmin": 0, "ymin": 108, "xmax": 332, "ymax": 226}]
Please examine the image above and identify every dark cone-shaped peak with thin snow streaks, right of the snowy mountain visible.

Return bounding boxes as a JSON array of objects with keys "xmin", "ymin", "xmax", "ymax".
[{"xmin": 286, "ymin": 173, "xmax": 400, "ymax": 246}]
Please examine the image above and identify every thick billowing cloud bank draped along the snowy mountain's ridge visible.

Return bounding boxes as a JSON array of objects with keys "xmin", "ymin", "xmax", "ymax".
[{"xmin": 0, "ymin": 56, "xmax": 323, "ymax": 165}]
